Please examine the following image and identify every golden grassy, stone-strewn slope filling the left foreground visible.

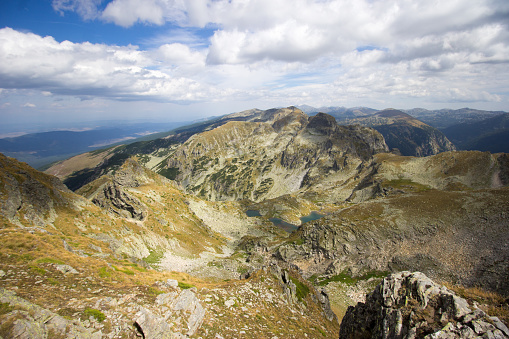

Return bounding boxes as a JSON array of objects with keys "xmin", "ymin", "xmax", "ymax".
[{"xmin": 0, "ymin": 153, "xmax": 338, "ymax": 338}]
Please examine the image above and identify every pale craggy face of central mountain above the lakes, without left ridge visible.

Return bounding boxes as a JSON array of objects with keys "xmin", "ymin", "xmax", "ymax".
[{"xmin": 165, "ymin": 108, "xmax": 388, "ymax": 201}]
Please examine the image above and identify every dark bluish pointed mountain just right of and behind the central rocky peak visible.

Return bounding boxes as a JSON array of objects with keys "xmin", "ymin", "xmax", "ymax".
[{"xmin": 342, "ymin": 109, "xmax": 455, "ymax": 157}]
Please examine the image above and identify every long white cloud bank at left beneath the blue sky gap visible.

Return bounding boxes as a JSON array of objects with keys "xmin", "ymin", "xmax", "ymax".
[{"xmin": 0, "ymin": 28, "xmax": 215, "ymax": 102}]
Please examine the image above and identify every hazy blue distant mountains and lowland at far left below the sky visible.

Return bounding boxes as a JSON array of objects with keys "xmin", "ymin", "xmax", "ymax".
[{"xmin": 0, "ymin": 123, "xmax": 184, "ymax": 167}]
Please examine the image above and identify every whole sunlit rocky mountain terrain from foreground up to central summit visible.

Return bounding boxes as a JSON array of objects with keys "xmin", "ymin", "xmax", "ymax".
[{"xmin": 0, "ymin": 107, "xmax": 509, "ymax": 339}]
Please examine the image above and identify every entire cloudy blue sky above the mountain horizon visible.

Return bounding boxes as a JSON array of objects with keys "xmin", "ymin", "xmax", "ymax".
[{"xmin": 0, "ymin": 0, "xmax": 509, "ymax": 132}]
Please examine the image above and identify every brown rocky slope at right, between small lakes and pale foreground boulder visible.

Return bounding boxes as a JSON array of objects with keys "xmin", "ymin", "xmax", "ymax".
[{"xmin": 277, "ymin": 188, "xmax": 509, "ymax": 294}]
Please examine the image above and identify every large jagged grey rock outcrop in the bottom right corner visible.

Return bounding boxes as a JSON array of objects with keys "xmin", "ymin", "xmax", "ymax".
[{"xmin": 339, "ymin": 272, "xmax": 509, "ymax": 339}]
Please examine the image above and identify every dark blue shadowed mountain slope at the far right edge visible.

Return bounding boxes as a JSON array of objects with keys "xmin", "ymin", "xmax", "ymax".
[{"xmin": 443, "ymin": 113, "xmax": 509, "ymax": 153}]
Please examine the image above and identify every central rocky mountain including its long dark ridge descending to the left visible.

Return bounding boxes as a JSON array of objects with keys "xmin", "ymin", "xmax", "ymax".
[{"xmin": 48, "ymin": 107, "xmax": 388, "ymax": 197}]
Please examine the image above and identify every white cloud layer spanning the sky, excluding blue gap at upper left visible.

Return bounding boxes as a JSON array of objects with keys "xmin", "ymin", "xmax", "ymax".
[{"xmin": 4, "ymin": 0, "xmax": 509, "ymax": 111}]
